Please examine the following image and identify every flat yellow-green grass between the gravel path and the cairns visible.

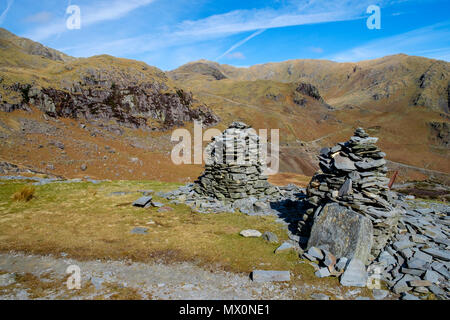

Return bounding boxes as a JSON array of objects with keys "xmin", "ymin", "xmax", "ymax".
[{"xmin": 0, "ymin": 181, "xmax": 376, "ymax": 298}]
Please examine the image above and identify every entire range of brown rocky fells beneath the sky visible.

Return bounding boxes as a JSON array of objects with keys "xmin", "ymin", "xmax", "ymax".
[{"xmin": 0, "ymin": 29, "xmax": 450, "ymax": 184}]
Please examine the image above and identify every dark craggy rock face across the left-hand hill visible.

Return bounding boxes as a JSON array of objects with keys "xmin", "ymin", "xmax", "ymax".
[{"xmin": 0, "ymin": 79, "xmax": 219, "ymax": 130}]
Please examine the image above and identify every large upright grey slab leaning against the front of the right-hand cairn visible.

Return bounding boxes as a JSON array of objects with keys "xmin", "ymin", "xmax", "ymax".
[{"xmin": 308, "ymin": 203, "xmax": 373, "ymax": 264}]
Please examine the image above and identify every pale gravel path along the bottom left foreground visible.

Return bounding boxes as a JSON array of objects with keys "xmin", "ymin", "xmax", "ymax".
[{"xmin": 0, "ymin": 253, "xmax": 310, "ymax": 299}]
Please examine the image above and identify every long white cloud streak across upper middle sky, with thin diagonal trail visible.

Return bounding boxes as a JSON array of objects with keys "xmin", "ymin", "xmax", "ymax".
[{"xmin": 59, "ymin": 0, "xmax": 372, "ymax": 59}]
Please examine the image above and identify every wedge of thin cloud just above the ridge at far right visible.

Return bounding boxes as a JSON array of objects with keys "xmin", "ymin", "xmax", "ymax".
[{"xmin": 324, "ymin": 21, "xmax": 450, "ymax": 62}]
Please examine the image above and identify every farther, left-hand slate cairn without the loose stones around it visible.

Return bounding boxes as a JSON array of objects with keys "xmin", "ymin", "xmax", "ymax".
[{"xmin": 194, "ymin": 122, "xmax": 277, "ymax": 202}]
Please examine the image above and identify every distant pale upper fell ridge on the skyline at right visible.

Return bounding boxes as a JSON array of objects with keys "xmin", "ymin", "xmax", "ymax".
[{"xmin": 169, "ymin": 54, "xmax": 450, "ymax": 113}]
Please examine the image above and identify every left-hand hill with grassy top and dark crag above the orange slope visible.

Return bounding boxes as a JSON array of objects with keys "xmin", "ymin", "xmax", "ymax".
[{"xmin": 0, "ymin": 29, "xmax": 219, "ymax": 130}]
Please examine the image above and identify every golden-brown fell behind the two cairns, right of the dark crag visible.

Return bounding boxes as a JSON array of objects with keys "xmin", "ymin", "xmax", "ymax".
[{"xmin": 168, "ymin": 54, "xmax": 450, "ymax": 178}]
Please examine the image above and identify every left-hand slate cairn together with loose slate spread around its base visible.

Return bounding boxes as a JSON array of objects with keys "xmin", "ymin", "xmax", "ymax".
[{"xmin": 158, "ymin": 122, "xmax": 302, "ymax": 215}]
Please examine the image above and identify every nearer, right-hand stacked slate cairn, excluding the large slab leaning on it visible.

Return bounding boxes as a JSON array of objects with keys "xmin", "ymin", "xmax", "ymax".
[{"xmin": 299, "ymin": 128, "xmax": 399, "ymax": 257}]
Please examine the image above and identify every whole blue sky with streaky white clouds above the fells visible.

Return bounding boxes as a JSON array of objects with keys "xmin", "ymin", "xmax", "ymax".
[{"xmin": 0, "ymin": 0, "xmax": 450, "ymax": 70}]
